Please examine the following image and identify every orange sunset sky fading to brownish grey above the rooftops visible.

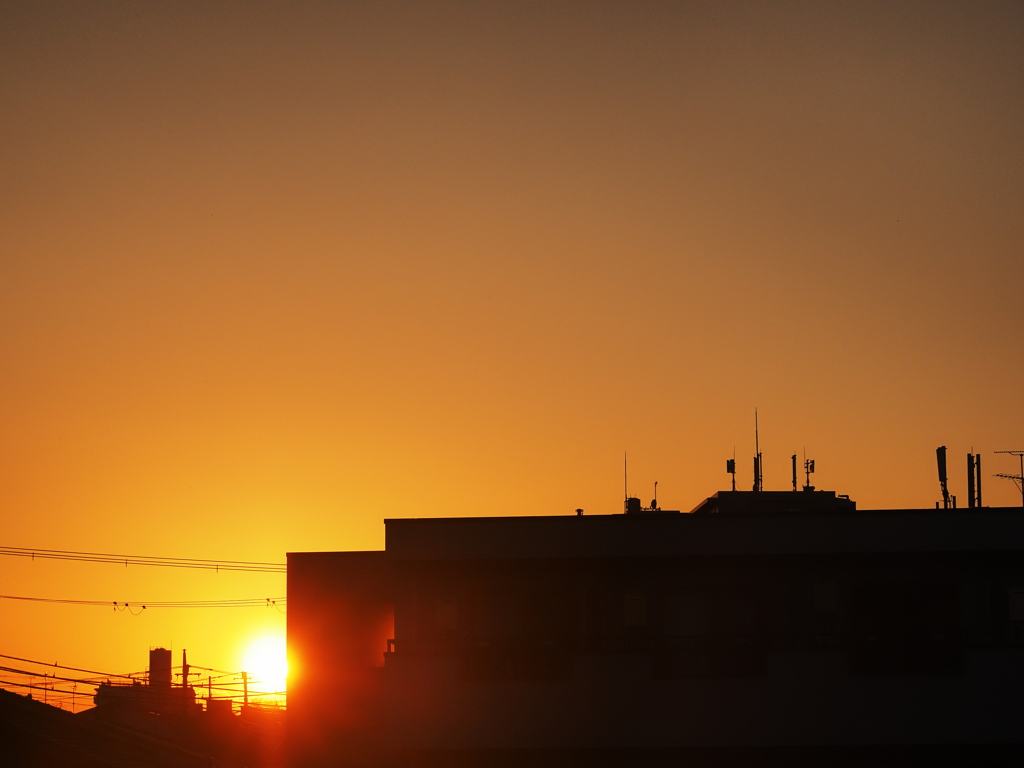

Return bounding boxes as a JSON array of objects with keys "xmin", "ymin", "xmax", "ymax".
[{"xmin": 0, "ymin": 0, "xmax": 1024, "ymax": 692}]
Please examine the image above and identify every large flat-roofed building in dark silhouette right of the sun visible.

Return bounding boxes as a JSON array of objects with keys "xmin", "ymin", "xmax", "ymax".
[{"xmin": 288, "ymin": 489, "xmax": 1024, "ymax": 768}]
